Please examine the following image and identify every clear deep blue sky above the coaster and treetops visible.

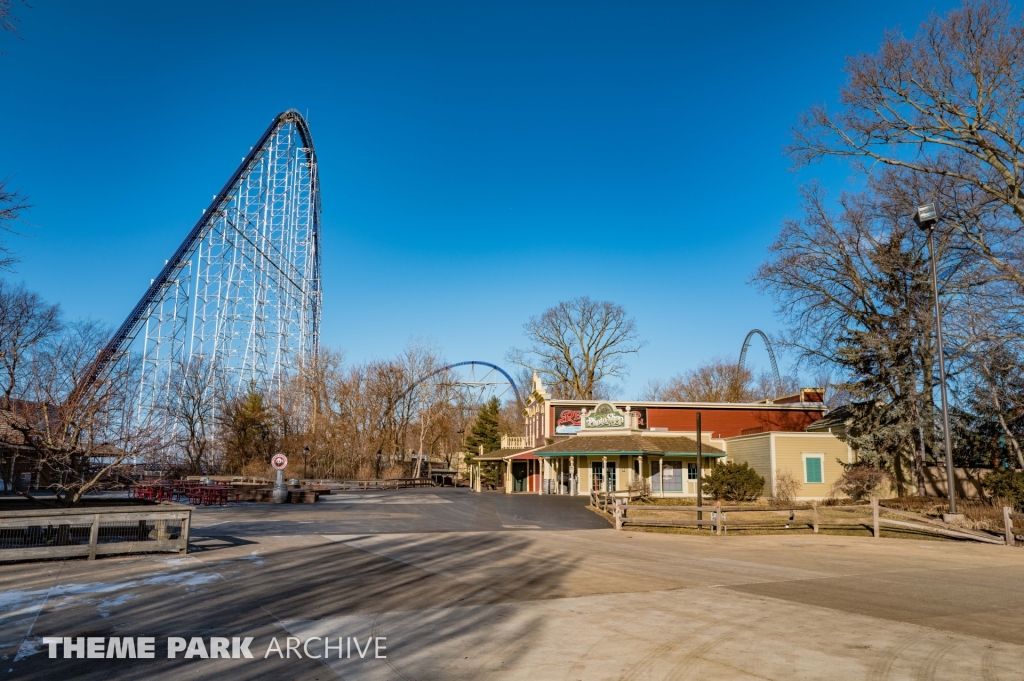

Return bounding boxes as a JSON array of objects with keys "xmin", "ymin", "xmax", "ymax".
[{"xmin": 0, "ymin": 0, "xmax": 954, "ymax": 397}]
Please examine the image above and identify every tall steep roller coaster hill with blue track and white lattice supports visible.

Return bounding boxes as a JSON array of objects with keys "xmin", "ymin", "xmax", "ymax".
[{"xmin": 84, "ymin": 110, "xmax": 322, "ymax": 412}]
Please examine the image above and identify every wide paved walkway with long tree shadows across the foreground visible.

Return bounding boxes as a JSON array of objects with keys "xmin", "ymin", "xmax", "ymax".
[{"xmin": 0, "ymin": 490, "xmax": 1024, "ymax": 681}]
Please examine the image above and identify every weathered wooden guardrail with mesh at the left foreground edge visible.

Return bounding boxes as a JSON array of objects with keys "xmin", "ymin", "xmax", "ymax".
[{"xmin": 0, "ymin": 504, "xmax": 193, "ymax": 562}]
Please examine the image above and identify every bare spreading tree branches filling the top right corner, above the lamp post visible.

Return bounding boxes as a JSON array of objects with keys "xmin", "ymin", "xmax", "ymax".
[{"xmin": 788, "ymin": 0, "xmax": 1024, "ymax": 303}]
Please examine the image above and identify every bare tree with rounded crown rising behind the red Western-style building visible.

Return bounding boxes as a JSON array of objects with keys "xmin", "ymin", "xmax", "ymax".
[{"xmin": 508, "ymin": 296, "xmax": 646, "ymax": 399}]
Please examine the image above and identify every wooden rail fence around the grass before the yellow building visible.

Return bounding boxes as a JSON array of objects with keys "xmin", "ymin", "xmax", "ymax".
[{"xmin": 610, "ymin": 494, "xmax": 1011, "ymax": 546}]
